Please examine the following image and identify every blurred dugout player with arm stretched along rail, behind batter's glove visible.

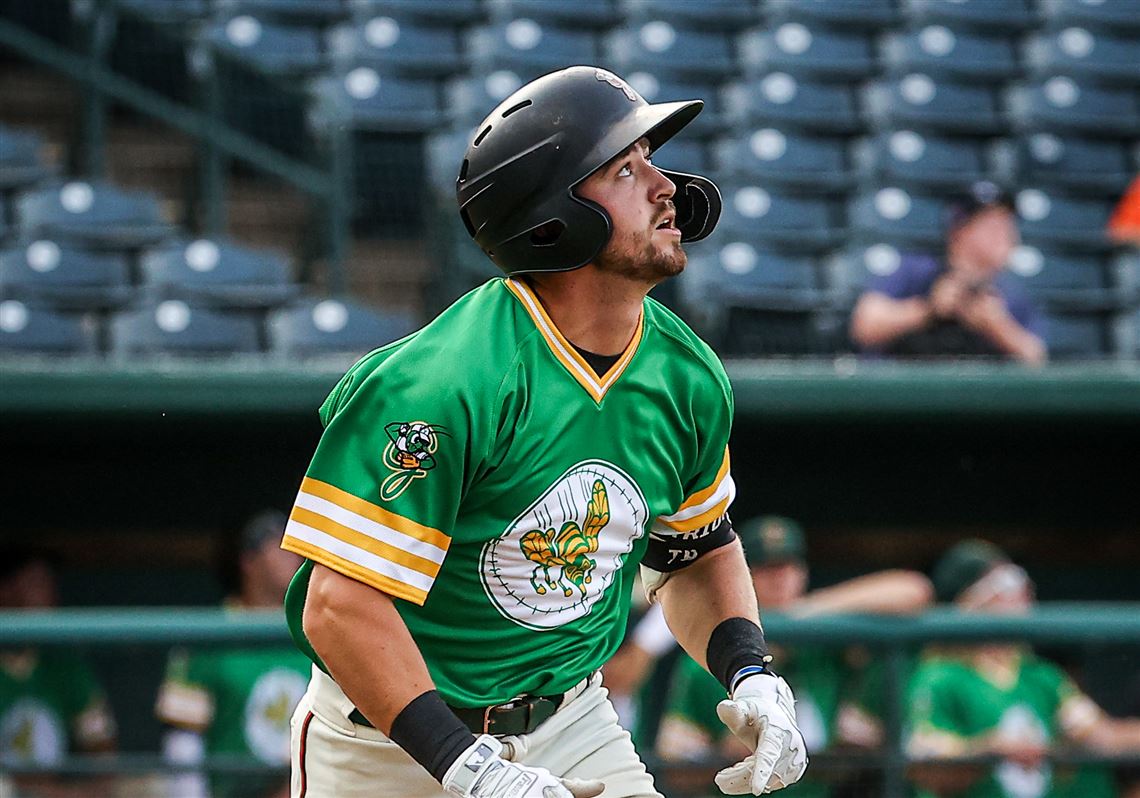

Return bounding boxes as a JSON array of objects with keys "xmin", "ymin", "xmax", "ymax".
[{"xmin": 608, "ymin": 515, "xmax": 934, "ymax": 797}]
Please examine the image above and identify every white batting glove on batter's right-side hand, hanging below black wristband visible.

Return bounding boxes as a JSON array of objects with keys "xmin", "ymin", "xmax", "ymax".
[{"xmin": 716, "ymin": 674, "xmax": 807, "ymax": 796}]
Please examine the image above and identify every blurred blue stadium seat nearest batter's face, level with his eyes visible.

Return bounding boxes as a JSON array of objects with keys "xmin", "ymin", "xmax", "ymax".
[{"xmin": 714, "ymin": 128, "xmax": 853, "ymax": 190}]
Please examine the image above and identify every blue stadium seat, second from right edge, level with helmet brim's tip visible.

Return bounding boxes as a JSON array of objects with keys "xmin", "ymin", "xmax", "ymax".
[{"xmin": 864, "ymin": 72, "xmax": 1004, "ymax": 135}]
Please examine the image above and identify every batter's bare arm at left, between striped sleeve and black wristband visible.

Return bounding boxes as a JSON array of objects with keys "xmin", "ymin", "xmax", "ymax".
[{"xmin": 303, "ymin": 564, "xmax": 434, "ymax": 733}]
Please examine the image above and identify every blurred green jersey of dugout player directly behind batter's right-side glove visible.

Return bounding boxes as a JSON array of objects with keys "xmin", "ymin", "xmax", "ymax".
[{"xmin": 665, "ymin": 648, "xmax": 846, "ymax": 798}]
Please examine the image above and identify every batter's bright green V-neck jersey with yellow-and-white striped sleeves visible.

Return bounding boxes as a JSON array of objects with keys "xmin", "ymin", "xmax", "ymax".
[{"xmin": 282, "ymin": 279, "xmax": 735, "ymax": 707}]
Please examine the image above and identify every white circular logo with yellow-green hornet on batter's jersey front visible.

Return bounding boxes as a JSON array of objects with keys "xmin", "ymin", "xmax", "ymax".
[{"xmin": 480, "ymin": 461, "xmax": 649, "ymax": 629}]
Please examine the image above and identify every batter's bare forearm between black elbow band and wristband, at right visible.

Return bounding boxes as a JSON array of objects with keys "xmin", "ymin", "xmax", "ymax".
[{"xmin": 658, "ymin": 540, "xmax": 760, "ymax": 668}]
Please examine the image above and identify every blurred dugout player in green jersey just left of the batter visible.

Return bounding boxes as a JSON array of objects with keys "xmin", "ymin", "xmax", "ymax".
[{"xmin": 155, "ymin": 510, "xmax": 310, "ymax": 798}]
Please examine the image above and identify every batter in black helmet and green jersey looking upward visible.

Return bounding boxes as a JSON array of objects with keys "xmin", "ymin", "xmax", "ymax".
[{"xmin": 282, "ymin": 66, "xmax": 807, "ymax": 798}]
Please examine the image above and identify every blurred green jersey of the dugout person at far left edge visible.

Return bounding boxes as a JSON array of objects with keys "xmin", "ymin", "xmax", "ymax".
[{"xmin": 0, "ymin": 650, "xmax": 115, "ymax": 765}]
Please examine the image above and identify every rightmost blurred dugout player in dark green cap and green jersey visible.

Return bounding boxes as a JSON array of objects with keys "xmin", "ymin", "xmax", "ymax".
[{"xmin": 906, "ymin": 540, "xmax": 1140, "ymax": 798}]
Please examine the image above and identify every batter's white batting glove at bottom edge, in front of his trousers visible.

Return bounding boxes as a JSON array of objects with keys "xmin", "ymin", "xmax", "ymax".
[{"xmin": 443, "ymin": 734, "xmax": 605, "ymax": 798}]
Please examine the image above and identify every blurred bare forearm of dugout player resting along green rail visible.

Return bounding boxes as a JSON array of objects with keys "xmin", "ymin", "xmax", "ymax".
[{"xmin": 792, "ymin": 570, "xmax": 934, "ymax": 617}]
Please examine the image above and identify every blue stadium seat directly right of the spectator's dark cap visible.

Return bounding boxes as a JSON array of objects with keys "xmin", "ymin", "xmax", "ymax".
[{"xmin": 1017, "ymin": 188, "xmax": 1112, "ymax": 250}]
